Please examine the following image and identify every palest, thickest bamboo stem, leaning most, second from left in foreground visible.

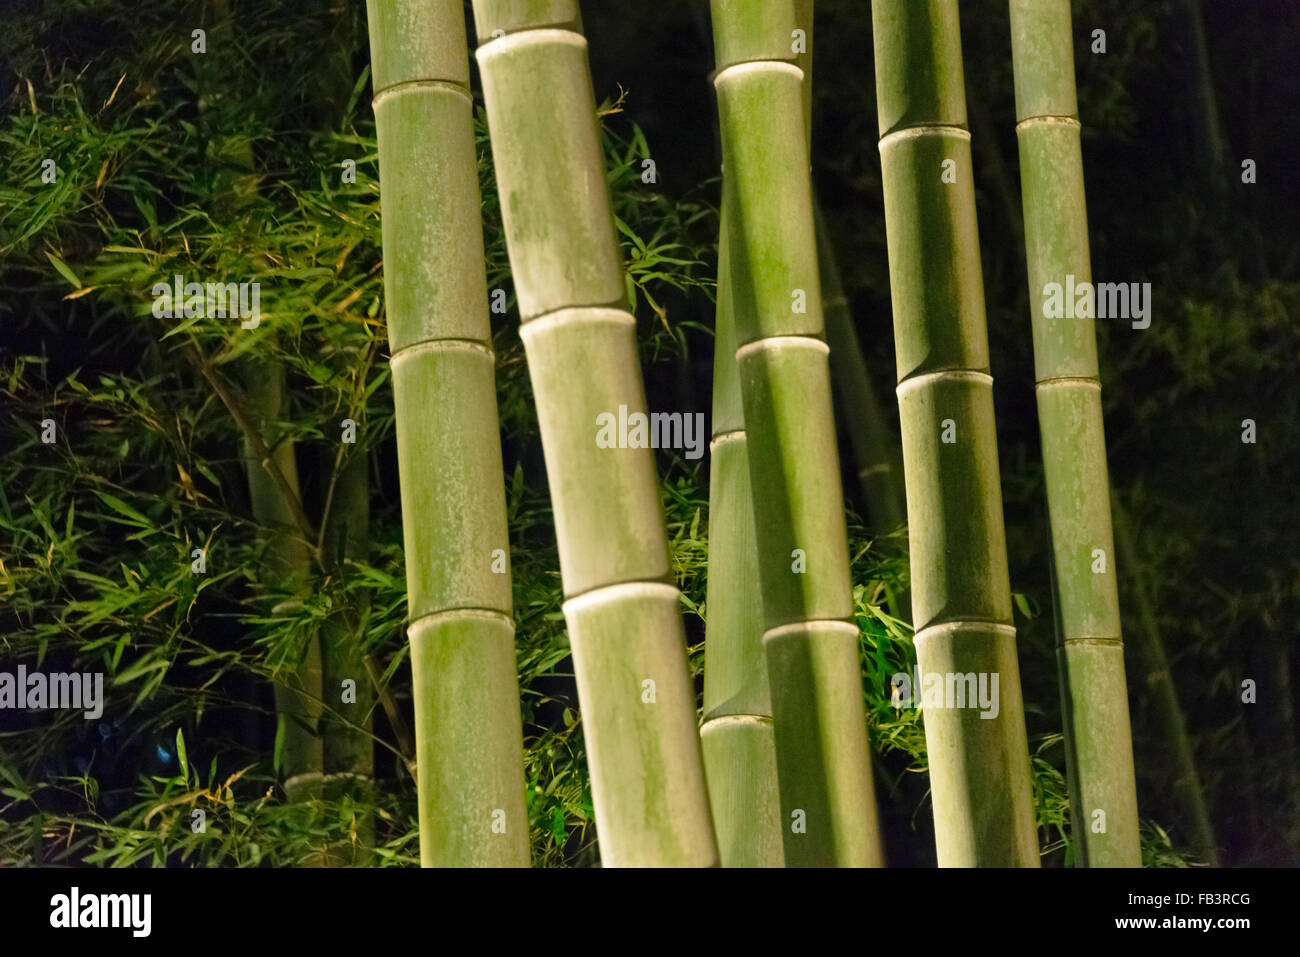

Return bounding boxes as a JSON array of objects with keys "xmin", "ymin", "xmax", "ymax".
[{"xmin": 475, "ymin": 0, "xmax": 718, "ymax": 866}]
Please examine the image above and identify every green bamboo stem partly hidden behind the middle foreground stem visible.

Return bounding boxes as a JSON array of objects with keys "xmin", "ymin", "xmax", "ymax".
[{"xmin": 699, "ymin": 211, "xmax": 785, "ymax": 867}]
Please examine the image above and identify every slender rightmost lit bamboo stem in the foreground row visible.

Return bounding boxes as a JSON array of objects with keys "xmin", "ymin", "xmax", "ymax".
[{"xmin": 1010, "ymin": 0, "xmax": 1141, "ymax": 867}]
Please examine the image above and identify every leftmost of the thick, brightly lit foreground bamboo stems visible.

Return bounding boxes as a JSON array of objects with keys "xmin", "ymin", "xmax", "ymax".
[{"xmin": 368, "ymin": 0, "xmax": 529, "ymax": 867}]
